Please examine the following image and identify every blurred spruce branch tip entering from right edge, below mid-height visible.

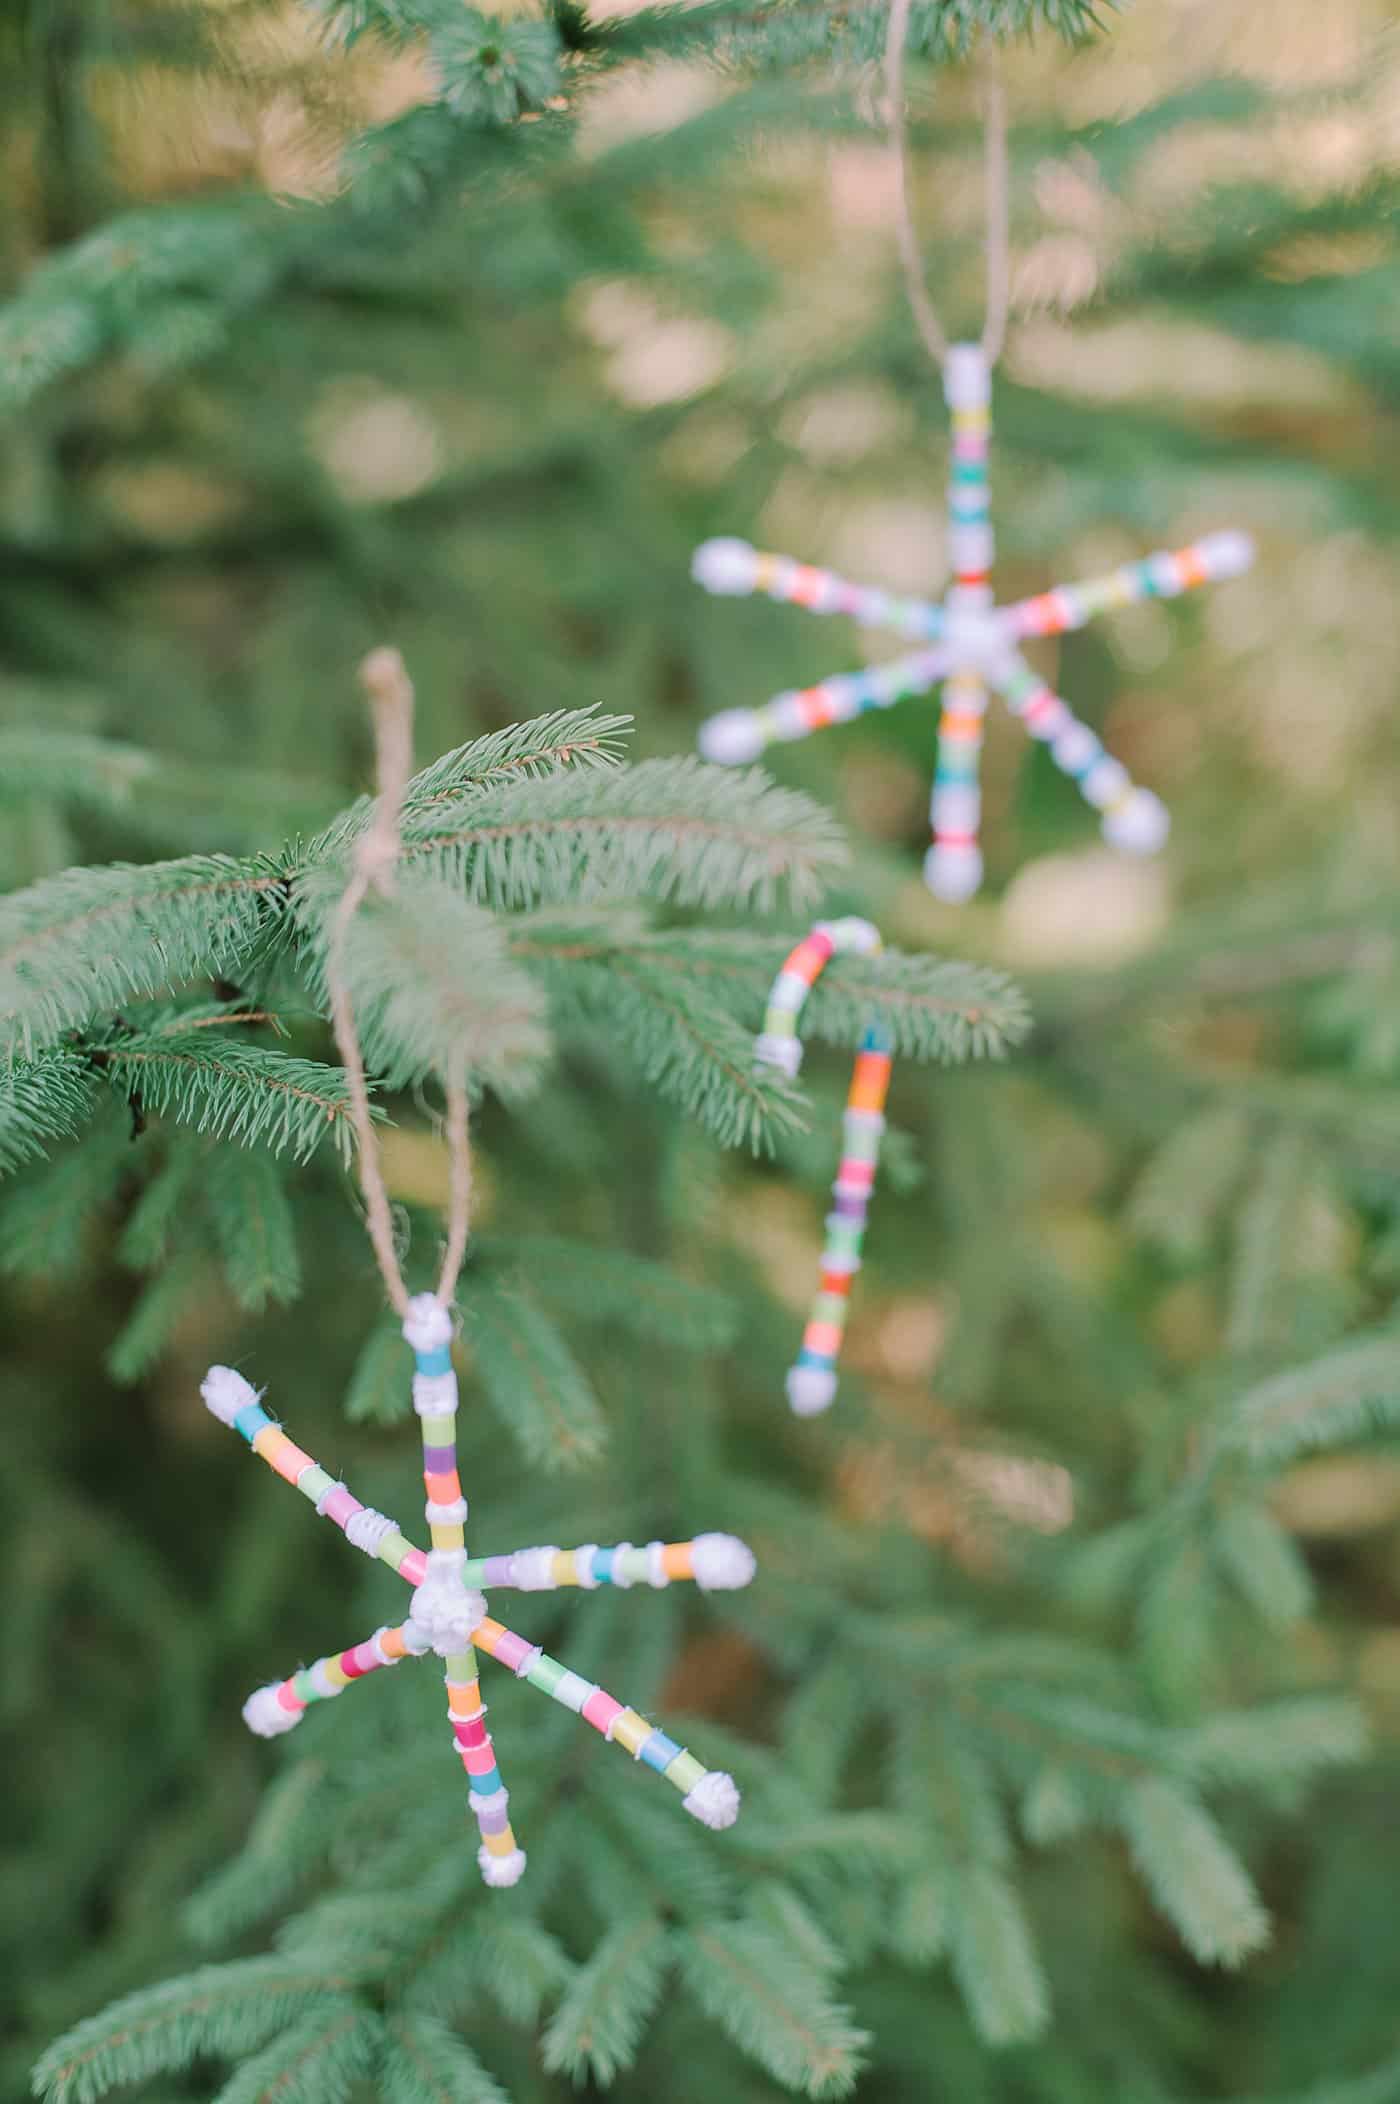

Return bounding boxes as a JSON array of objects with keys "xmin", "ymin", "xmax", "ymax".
[{"xmin": 1221, "ymin": 1330, "xmax": 1400, "ymax": 1466}]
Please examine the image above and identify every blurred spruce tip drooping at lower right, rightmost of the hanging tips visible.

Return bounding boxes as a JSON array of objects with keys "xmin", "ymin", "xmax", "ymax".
[{"xmin": 1122, "ymin": 1776, "xmax": 1269, "ymax": 1965}]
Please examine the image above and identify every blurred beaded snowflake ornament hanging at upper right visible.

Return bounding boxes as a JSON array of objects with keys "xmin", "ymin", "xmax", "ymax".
[{"xmin": 693, "ymin": 343, "xmax": 1255, "ymax": 901}]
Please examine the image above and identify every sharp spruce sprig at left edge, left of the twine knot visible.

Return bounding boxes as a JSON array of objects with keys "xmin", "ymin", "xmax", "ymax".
[{"xmin": 0, "ymin": 854, "xmax": 282, "ymax": 1058}]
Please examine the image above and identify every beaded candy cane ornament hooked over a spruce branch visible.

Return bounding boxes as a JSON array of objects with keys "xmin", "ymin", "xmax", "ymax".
[{"xmin": 754, "ymin": 919, "xmax": 891, "ymax": 1418}]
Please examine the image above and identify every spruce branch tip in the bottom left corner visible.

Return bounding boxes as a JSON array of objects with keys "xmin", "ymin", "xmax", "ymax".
[{"xmin": 34, "ymin": 1959, "xmax": 362, "ymax": 2104}]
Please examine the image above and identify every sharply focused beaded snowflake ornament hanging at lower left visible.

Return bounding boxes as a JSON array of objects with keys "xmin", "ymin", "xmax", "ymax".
[{"xmin": 200, "ymin": 1294, "xmax": 754, "ymax": 1885}]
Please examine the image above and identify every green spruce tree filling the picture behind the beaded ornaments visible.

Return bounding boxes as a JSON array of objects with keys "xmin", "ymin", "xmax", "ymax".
[{"xmin": 0, "ymin": 0, "xmax": 1400, "ymax": 2104}]
